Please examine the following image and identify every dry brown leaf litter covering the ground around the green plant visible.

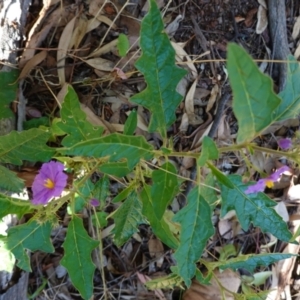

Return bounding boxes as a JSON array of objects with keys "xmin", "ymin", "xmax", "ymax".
[{"xmin": 4, "ymin": 0, "xmax": 299, "ymax": 300}]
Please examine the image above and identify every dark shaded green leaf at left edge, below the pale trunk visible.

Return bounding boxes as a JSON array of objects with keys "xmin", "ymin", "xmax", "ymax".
[{"xmin": 0, "ymin": 70, "xmax": 19, "ymax": 119}]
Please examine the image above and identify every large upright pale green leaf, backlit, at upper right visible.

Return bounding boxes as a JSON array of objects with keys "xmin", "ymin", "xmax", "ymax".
[{"xmin": 227, "ymin": 44, "xmax": 281, "ymax": 143}]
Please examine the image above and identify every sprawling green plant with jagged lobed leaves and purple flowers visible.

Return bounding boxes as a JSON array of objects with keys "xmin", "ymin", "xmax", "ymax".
[{"xmin": 0, "ymin": 0, "xmax": 300, "ymax": 299}]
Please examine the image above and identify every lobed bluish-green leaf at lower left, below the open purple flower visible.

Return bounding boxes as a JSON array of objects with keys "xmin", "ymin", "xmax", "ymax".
[{"xmin": 6, "ymin": 221, "xmax": 54, "ymax": 272}]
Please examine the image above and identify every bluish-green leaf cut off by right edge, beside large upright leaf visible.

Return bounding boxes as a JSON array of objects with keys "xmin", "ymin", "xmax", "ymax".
[{"xmin": 274, "ymin": 55, "xmax": 300, "ymax": 121}]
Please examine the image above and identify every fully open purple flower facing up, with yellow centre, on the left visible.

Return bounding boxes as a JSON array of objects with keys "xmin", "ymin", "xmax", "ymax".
[{"xmin": 32, "ymin": 161, "xmax": 68, "ymax": 205}]
